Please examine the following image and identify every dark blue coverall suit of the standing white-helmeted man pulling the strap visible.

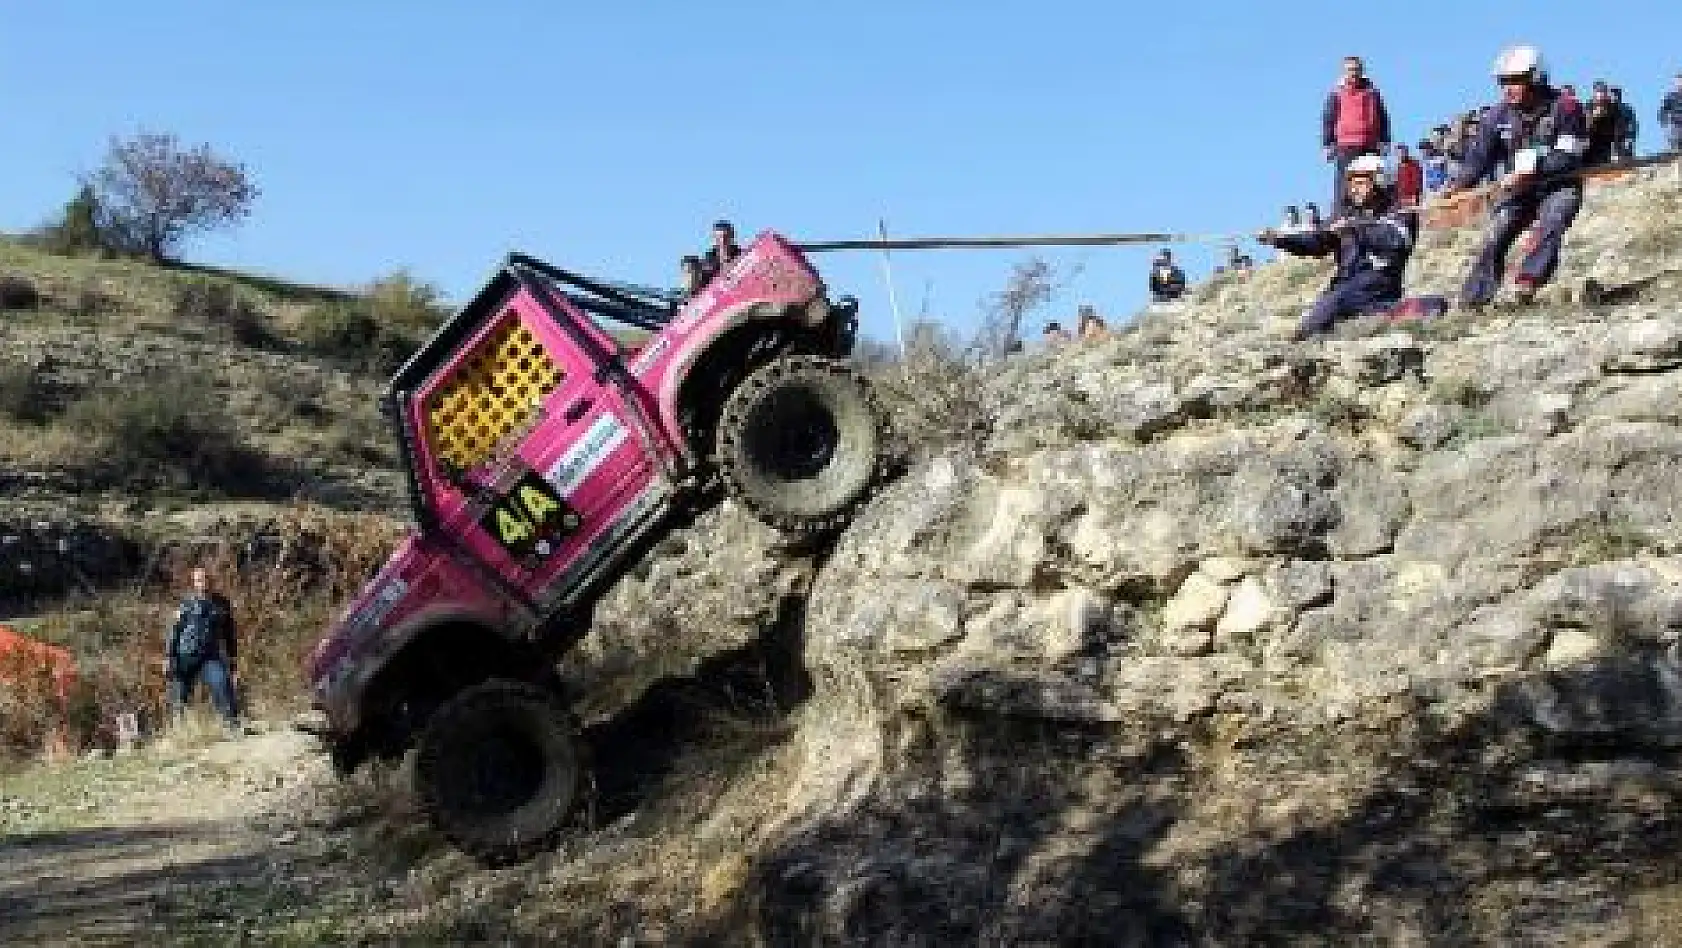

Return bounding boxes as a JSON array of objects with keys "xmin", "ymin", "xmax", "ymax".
[{"xmin": 1453, "ymin": 86, "xmax": 1588, "ymax": 306}]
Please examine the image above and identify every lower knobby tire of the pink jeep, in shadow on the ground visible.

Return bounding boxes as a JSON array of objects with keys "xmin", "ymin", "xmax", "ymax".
[{"xmin": 414, "ymin": 681, "xmax": 584, "ymax": 866}]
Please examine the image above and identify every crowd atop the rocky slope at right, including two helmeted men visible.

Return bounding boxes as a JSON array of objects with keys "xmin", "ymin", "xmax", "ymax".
[{"xmin": 1103, "ymin": 45, "xmax": 1682, "ymax": 346}]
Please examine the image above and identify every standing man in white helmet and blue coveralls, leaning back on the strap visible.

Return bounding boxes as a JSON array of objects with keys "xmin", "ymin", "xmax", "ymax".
[{"xmin": 1443, "ymin": 45, "xmax": 1588, "ymax": 306}]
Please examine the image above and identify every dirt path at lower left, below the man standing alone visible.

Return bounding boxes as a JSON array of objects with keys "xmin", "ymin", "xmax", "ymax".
[{"xmin": 0, "ymin": 729, "xmax": 361, "ymax": 945}]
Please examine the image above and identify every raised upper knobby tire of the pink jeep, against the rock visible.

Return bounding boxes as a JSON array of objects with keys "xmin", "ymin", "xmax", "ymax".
[{"xmin": 715, "ymin": 355, "xmax": 886, "ymax": 535}]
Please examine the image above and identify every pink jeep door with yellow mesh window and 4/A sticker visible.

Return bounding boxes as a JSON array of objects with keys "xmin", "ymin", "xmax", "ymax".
[{"xmin": 409, "ymin": 284, "xmax": 664, "ymax": 605}]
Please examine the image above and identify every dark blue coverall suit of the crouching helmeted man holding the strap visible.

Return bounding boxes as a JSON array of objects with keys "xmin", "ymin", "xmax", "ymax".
[{"xmin": 1272, "ymin": 200, "xmax": 1420, "ymax": 334}]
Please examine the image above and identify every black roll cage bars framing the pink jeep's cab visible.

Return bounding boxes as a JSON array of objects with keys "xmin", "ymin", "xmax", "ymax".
[{"xmin": 380, "ymin": 252, "xmax": 678, "ymax": 535}]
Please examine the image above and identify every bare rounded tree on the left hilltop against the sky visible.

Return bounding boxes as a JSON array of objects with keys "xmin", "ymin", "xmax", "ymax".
[{"xmin": 87, "ymin": 131, "xmax": 257, "ymax": 262}]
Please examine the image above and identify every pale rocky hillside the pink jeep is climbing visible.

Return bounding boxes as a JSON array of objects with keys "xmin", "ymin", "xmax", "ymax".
[{"xmin": 7, "ymin": 168, "xmax": 1682, "ymax": 945}]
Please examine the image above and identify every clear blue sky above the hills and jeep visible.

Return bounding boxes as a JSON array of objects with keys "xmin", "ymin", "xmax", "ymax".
[{"xmin": 0, "ymin": 0, "xmax": 1682, "ymax": 338}]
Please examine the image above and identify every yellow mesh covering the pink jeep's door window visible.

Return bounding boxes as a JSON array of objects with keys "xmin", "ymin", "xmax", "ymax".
[{"xmin": 427, "ymin": 319, "xmax": 562, "ymax": 471}]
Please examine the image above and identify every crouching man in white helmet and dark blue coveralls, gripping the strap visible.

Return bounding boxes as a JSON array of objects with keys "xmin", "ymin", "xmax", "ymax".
[{"xmin": 1256, "ymin": 155, "xmax": 1420, "ymax": 340}]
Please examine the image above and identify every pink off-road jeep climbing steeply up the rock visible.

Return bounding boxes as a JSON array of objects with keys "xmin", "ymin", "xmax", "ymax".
[{"xmin": 308, "ymin": 232, "xmax": 885, "ymax": 862}]
